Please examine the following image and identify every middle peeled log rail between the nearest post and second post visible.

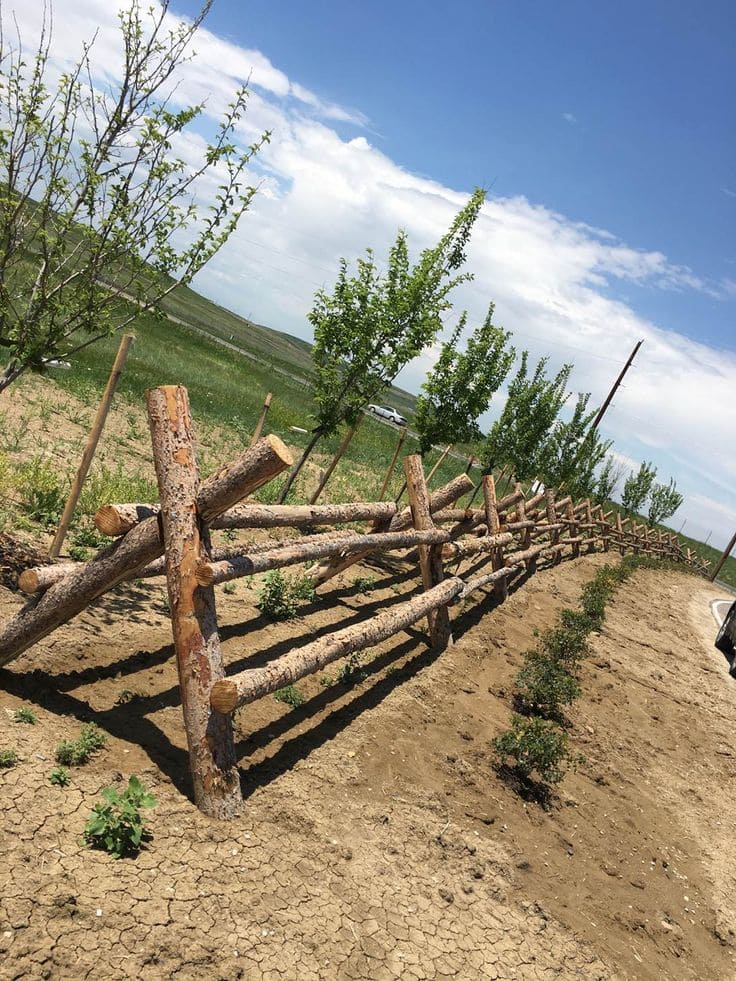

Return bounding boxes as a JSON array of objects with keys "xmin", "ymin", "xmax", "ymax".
[{"xmin": 197, "ymin": 528, "xmax": 450, "ymax": 586}]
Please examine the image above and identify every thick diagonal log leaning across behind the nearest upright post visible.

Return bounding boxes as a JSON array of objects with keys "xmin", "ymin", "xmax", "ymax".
[{"xmin": 0, "ymin": 435, "xmax": 292, "ymax": 667}]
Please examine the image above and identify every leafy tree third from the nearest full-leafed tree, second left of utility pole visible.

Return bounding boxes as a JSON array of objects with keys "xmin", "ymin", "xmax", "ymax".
[{"xmin": 481, "ymin": 351, "xmax": 572, "ymax": 480}]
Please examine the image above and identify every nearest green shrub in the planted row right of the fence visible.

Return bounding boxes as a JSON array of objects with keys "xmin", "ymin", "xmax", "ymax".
[{"xmin": 493, "ymin": 715, "xmax": 572, "ymax": 783}]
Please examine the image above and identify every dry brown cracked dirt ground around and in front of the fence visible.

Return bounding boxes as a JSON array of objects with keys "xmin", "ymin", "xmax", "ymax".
[{"xmin": 0, "ymin": 556, "xmax": 736, "ymax": 981}]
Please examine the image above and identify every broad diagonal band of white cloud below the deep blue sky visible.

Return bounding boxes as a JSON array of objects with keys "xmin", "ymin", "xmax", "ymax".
[{"xmin": 10, "ymin": 0, "xmax": 736, "ymax": 541}]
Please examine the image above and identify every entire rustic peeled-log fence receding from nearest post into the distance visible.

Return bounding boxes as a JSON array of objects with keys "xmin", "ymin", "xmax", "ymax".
[{"xmin": 0, "ymin": 386, "xmax": 705, "ymax": 819}]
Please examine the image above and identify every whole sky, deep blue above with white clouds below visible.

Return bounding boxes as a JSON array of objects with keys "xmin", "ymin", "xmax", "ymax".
[{"xmin": 27, "ymin": 0, "xmax": 736, "ymax": 544}]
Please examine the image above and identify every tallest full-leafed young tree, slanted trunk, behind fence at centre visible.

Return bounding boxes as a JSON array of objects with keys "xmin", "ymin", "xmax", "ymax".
[{"xmin": 279, "ymin": 189, "xmax": 485, "ymax": 501}]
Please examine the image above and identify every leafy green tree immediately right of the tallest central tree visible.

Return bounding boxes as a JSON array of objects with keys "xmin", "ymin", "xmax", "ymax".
[{"xmin": 414, "ymin": 303, "xmax": 516, "ymax": 456}]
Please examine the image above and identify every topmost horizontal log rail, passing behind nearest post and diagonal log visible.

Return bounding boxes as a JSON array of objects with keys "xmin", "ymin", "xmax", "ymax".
[{"xmin": 95, "ymin": 501, "xmax": 397, "ymax": 537}]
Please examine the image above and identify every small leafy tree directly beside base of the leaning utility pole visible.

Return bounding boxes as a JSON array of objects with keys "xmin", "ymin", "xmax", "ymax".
[{"xmin": 539, "ymin": 392, "xmax": 611, "ymax": 497}]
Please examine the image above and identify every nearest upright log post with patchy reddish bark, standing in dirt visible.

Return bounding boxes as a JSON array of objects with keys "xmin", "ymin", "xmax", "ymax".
[{"xmin": 146, "ymin": 385, "xmax": 242, "ymax": 820}]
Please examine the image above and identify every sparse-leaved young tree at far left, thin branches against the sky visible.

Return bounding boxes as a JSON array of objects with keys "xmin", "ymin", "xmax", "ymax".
[{"xmin": 0, "ymin": 0, "xmax": 269, "ymax": 391}]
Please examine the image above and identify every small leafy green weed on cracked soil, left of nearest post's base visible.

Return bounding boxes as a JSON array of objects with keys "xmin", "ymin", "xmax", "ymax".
[{"xmin": 84, "ymin": 776, "xmax": 156, "ymax": 858}]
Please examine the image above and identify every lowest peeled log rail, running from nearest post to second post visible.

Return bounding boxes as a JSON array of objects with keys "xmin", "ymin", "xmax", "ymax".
[{"xmin": 210, "ymin": 577, "xmax": 463, "ymax": 712}]
